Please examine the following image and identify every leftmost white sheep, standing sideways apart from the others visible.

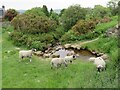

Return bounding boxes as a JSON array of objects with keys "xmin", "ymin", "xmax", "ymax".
[{"xmin": 19, "ymin": 49, "xmax": 36, "ymax": 62}]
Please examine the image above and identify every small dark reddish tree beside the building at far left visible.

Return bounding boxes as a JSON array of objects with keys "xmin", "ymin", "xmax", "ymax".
[{"xmin": 4, "ymin": 9, "xmax": 18, "ymax": 21}]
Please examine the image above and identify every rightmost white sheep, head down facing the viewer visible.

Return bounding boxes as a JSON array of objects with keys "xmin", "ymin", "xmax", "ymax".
[{"xmin": 94, "ymin": 57, "xmax": 106, "ymax": 72}]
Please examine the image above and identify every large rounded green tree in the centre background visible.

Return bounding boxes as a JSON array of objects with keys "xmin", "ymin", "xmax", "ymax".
[{"xmin": 61, "ymin": 5, "xmax": 86, "ymax": 31}]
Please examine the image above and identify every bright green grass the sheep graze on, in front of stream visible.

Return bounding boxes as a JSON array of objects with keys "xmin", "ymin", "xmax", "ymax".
[{"xmin": 2, "ymin": 22, "xmax": 118, "ymax": 88}]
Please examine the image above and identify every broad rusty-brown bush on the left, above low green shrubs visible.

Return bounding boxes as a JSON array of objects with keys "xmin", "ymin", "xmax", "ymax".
[{"xmin": 11, "ymin": 14, "xmax": 56, "ymax": 34}]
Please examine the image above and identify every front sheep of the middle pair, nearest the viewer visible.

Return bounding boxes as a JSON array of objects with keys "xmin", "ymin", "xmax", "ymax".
[{"xmin": 51, "ymin": 58, "xmax": 67, "ymax": 69}]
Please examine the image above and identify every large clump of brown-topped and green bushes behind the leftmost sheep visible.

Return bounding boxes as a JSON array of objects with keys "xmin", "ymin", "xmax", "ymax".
[{"xmin": 10, "ymin": 8, "xmax": 59, "ymax": 50}]
